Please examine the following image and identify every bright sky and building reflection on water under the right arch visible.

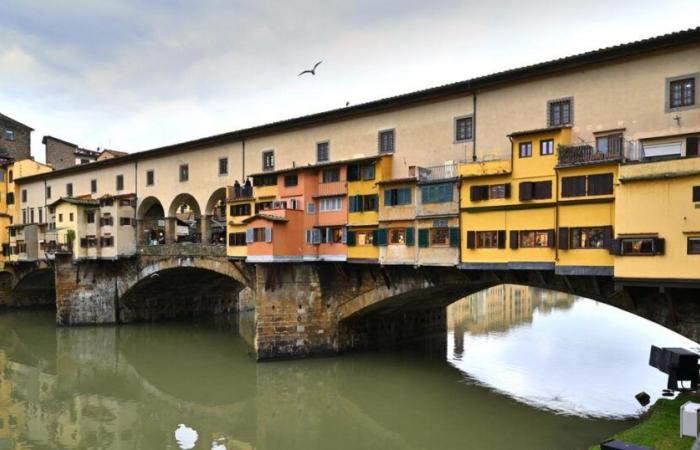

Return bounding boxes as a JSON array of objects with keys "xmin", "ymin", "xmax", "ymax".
[{"xmin": 448, "ymin": 285, "xmax": 697, "ymax": 417}]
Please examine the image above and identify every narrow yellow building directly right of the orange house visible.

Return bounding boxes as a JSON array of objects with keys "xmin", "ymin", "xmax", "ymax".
[{"xmin": 347, "ymin": 155, "xmax": 392, "ymax": 263}]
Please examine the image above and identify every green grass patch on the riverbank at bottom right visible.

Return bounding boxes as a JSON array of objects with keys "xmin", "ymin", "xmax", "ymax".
[{"xmin": 589, "ymin": 394, "xmax": 700, "ymax": 450}]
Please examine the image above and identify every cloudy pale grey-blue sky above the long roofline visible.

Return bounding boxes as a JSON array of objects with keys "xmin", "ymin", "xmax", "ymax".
[{"xmin": 0, "ymin": 0, "xmax": 700, "ymax": 160}]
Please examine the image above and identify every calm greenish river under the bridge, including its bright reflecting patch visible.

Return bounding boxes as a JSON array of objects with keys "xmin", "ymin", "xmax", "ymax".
[{"xmin": 0, "ymin": 286, "xmax": 697, "ymax": 450}]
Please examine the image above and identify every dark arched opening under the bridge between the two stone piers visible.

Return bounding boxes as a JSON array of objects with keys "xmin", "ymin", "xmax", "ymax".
[{"xmin": 117, "ymin": 267, "xmax": 243, "ymax": 323}]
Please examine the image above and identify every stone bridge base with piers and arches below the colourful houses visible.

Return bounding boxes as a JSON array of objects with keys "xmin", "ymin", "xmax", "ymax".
[{"xmin": 2, "ymin": 244, "xmax": 700, "ymax": 359}]
